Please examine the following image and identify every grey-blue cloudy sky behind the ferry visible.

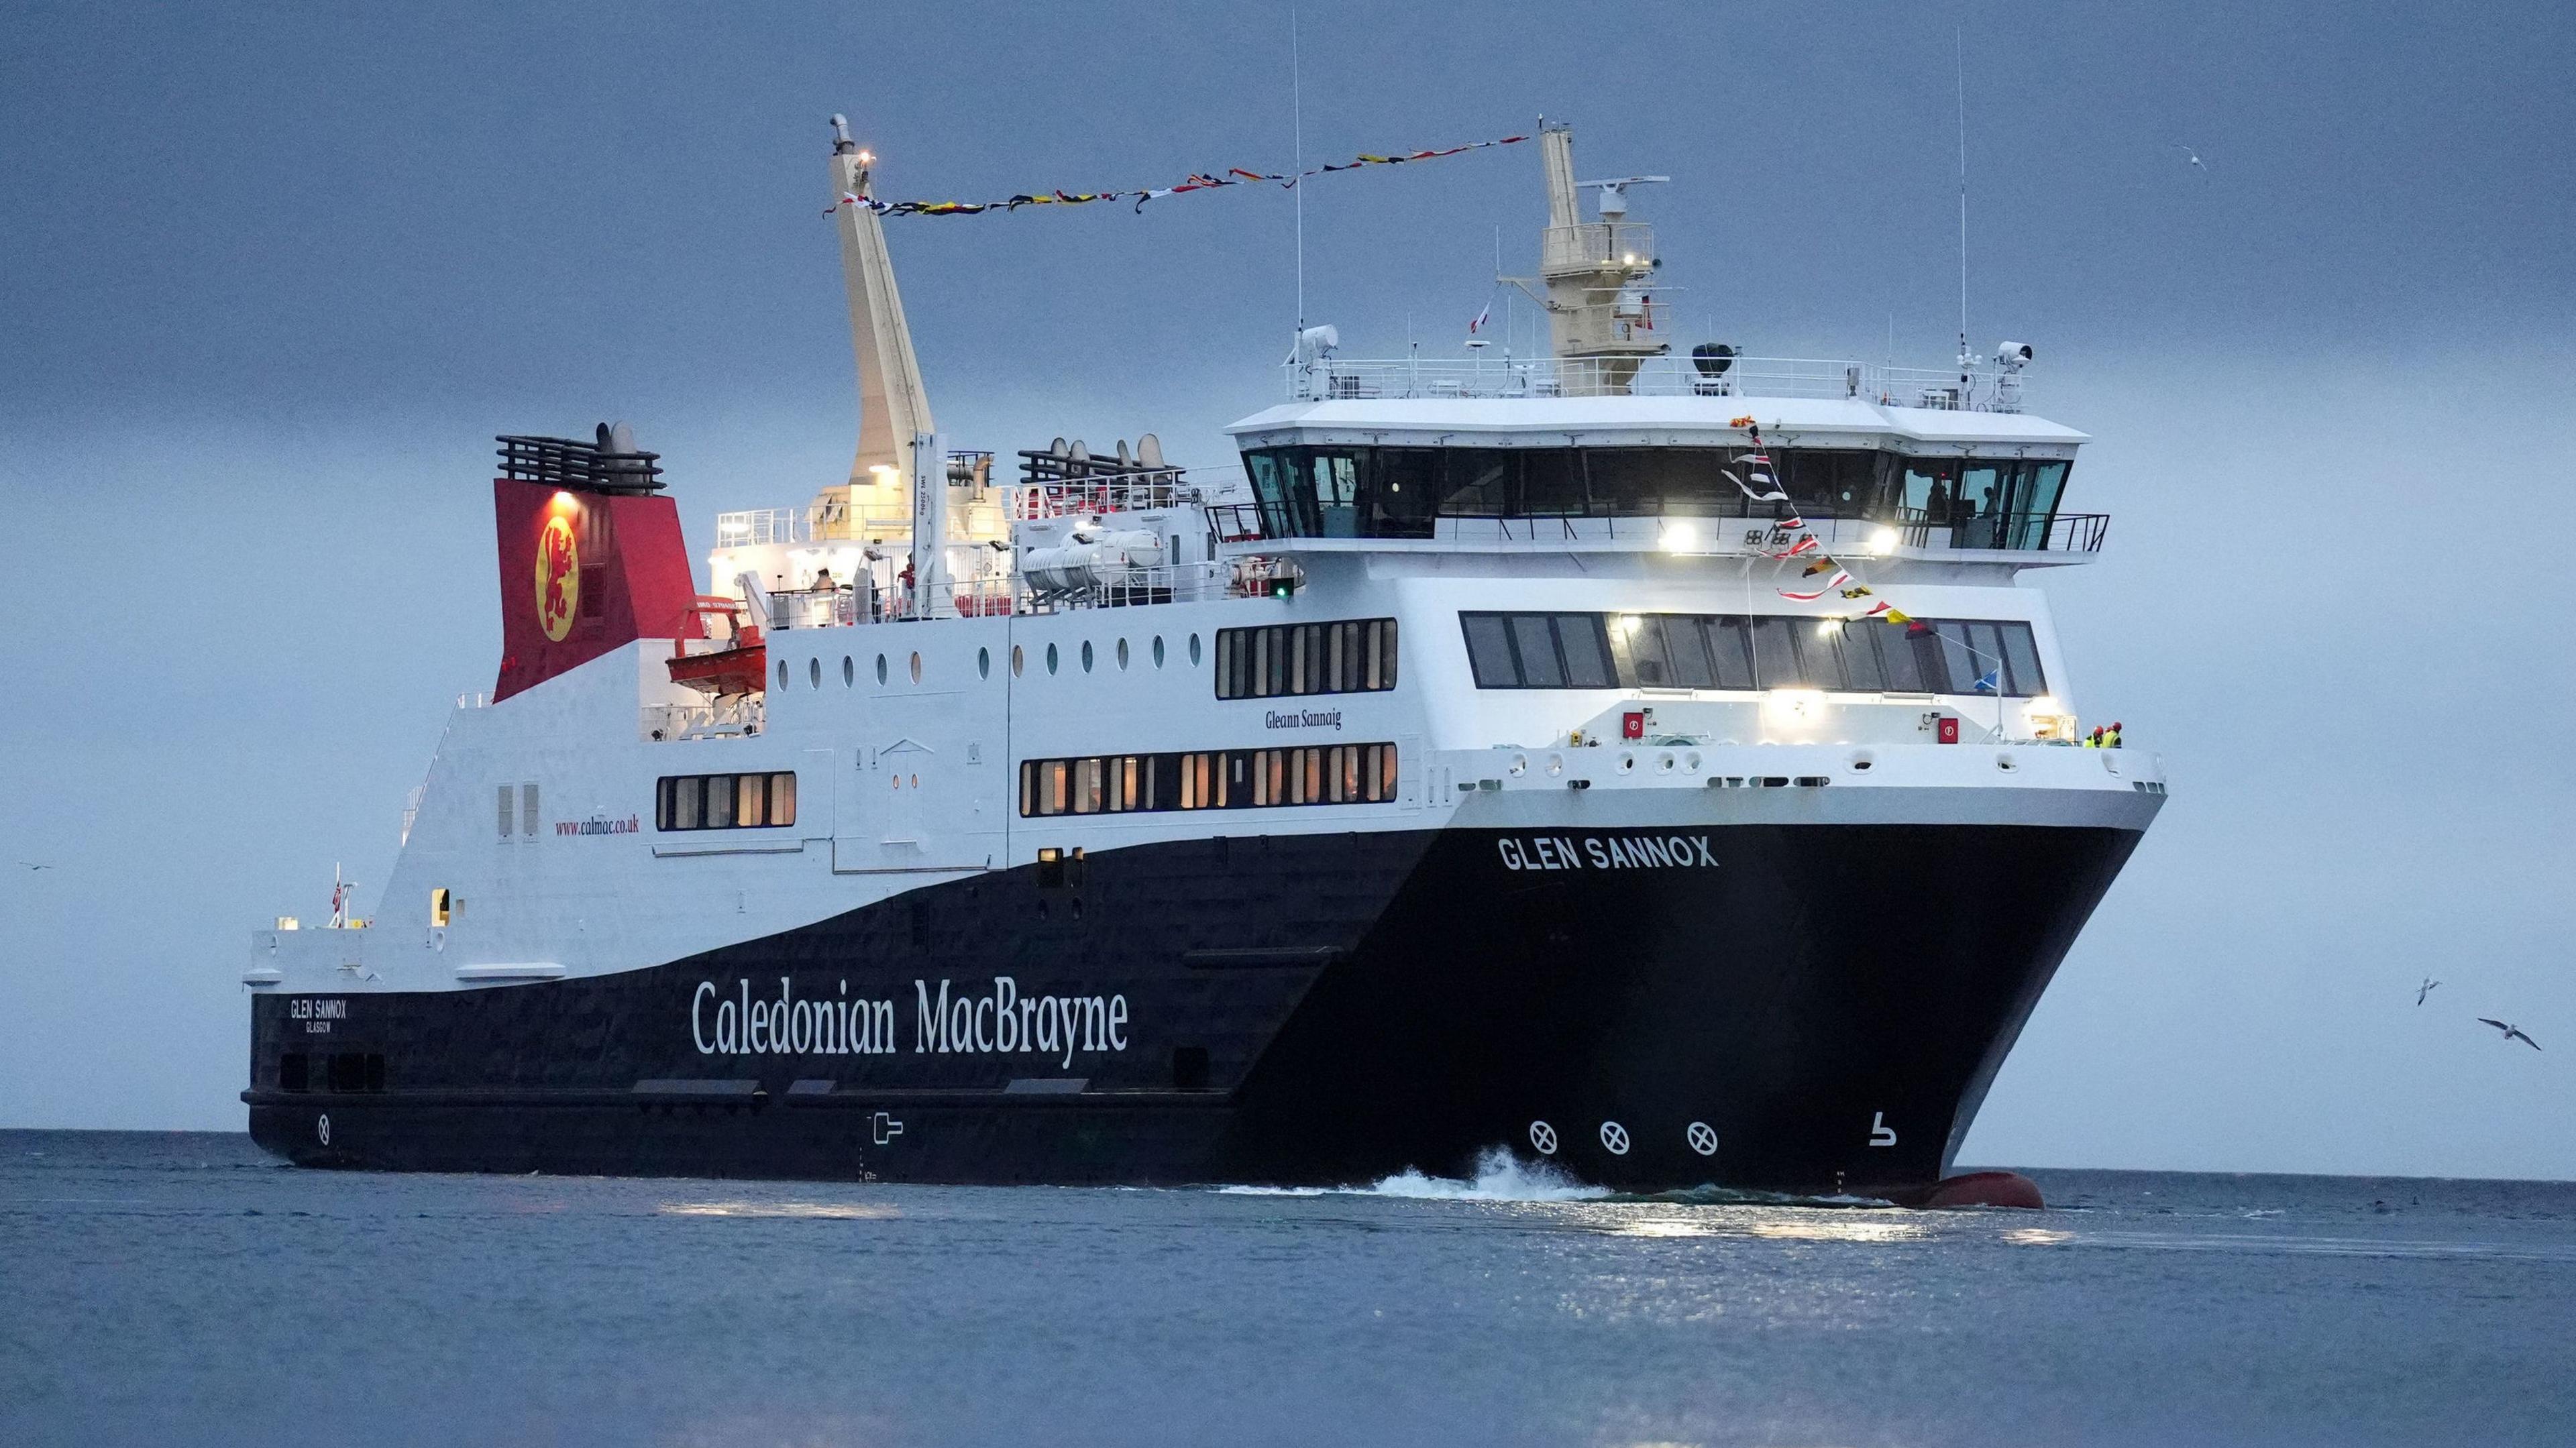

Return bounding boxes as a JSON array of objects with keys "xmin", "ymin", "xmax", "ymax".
[{"xmin": 0, "ymin": 3, "xmax": 2576, "ymax": 1175}]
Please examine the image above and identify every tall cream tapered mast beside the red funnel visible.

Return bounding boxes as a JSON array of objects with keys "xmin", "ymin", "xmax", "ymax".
[{"xmin": 827, "ymin": 116, "xmax": 932, "ymax": 512}]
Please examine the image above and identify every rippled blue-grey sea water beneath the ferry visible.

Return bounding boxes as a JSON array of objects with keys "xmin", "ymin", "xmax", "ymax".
[{"xmin": 0, "ymin": 1131, "xmax": 2576, "ymax": 1448}]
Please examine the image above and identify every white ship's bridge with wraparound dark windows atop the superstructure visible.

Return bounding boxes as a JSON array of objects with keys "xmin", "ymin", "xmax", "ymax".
[{"xmin": 1216, "ymin": 381, "xmax": 2110, "ymax": 567}]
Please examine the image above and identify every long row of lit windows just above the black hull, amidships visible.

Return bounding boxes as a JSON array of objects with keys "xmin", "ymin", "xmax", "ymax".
[{"xmin": 1020, "ymin": 744, "xmax": 1396, "ymax": 817}]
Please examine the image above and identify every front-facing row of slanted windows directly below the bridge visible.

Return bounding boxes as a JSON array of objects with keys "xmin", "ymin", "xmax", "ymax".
[{"xmin": 1458, "ymin": 613, "xmax": 2048, "ymax": 698}]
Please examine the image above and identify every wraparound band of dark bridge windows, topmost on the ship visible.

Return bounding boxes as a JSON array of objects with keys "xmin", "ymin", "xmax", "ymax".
[{"xmin": 1244, "ymin": 446, "xmax": 2069, "ymax": 538}]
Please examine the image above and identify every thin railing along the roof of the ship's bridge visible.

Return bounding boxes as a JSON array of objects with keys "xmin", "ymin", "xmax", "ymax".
[{"xmin": 1283, "ymin": 353, "xmax": 2022, "ymax": 412}]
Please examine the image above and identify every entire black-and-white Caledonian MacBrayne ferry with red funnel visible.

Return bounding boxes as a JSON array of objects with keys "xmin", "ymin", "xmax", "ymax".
[{"xmin": 242, "ymin": 119, "xmax": 2164, "ymax": 1201}]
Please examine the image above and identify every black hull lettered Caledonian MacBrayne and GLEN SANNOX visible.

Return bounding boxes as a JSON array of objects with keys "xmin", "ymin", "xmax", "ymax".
[{"xmin": 245, "ymin": 824, "xmax": 2138, "ymax": 1190}]
